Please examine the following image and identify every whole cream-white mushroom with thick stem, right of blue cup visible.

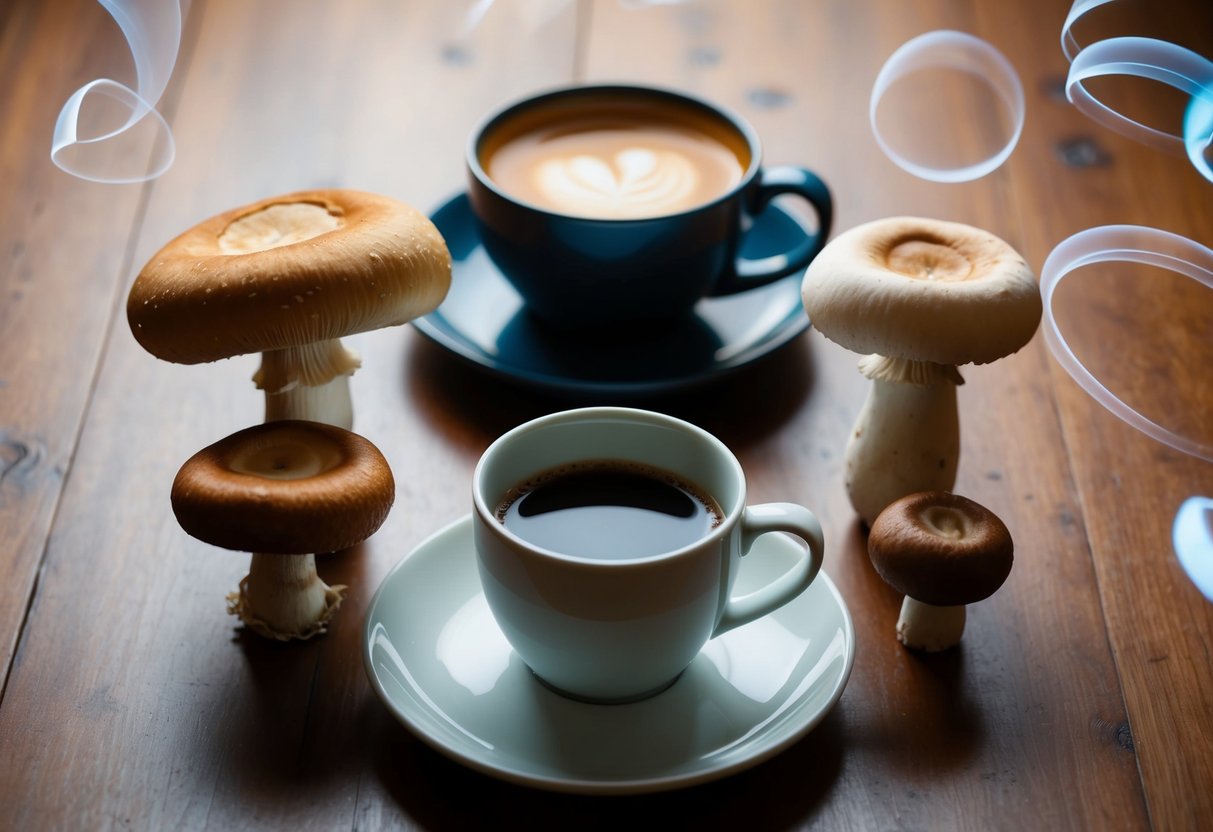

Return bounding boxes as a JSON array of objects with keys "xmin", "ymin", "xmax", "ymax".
[{"xmin": 802, "ymin": 217, "xmax": 1041, "ymax": 525}]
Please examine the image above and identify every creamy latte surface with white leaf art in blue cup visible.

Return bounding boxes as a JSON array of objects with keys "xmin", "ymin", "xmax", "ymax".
[{"xmin": 485, "ymin": 114, "xmax": 745, "ymax": 220}]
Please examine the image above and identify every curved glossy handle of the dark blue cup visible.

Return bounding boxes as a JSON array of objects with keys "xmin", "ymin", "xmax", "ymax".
[{"xmin": 710, "ymin": 165, "xmax": 833, "ymax": 296}]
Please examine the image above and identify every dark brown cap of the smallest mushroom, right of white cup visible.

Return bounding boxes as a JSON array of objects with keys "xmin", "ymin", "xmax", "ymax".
[{"xmin": 867, "ymin": 491, "xmax": 1014, "ymax": 606}]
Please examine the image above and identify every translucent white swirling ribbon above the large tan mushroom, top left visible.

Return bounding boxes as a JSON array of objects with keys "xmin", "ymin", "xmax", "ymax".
[{"xmin": 51, "ymin": 0, "xmax": 188, "ymax": 183}]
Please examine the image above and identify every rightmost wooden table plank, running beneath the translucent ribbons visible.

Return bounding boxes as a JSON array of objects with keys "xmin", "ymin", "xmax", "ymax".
[{"xmin": 983, "ymin": 4, "xmax": 1213, "ymax": 830}]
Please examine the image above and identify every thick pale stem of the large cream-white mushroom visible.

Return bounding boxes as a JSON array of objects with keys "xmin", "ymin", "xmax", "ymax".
[{"xmin": 845, "ymin": 355, "xmax": 964, "ymax": 525}]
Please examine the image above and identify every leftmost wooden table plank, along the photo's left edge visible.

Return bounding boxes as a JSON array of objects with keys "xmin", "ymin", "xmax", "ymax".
[{"xmin": 0, "ymin": 0, "xmax": 191, "ymax": 690}]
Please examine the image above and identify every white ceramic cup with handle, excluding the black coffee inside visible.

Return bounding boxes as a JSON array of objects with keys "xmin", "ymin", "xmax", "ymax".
[{"xmin": 472, "ymin": 408, "xmax": 824, "ymax": 702}]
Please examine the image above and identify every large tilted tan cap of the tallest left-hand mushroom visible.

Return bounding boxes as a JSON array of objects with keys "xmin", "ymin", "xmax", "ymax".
[{"xmin": 126, "ymin": 189, "xmax": 451, "ymax": 364}]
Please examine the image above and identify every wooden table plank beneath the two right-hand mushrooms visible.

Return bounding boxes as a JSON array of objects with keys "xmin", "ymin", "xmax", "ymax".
[{"xmin": 577, "ymin": 2, "xmax": 1147, "ymax": 828}]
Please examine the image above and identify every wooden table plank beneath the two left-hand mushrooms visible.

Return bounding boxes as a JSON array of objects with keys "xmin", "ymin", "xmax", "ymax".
[{"xmin": 0, "ymin": 1, "xmax": 574, "ymax": 830}]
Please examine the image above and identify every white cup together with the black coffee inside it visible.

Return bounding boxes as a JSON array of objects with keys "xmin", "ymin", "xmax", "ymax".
[{"xmin": 472, "ymin": 408, "xmax": 825, "ymax": 702}]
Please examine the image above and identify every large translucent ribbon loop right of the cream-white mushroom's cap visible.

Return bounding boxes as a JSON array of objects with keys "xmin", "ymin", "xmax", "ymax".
[{"xmin": 1041, "ymin": 226, "xmax": 1213, "ymax": 462}]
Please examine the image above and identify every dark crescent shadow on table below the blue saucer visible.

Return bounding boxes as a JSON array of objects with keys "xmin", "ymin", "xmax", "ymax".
[{"xmin": 404, "ymin": 327, "xmax": 813, "ymax": 455}]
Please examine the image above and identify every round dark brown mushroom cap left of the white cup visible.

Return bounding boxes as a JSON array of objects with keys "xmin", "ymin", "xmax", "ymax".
[{"xmin": 172, "ymin": 420, "xmax": 395, "ymax": 554}]
